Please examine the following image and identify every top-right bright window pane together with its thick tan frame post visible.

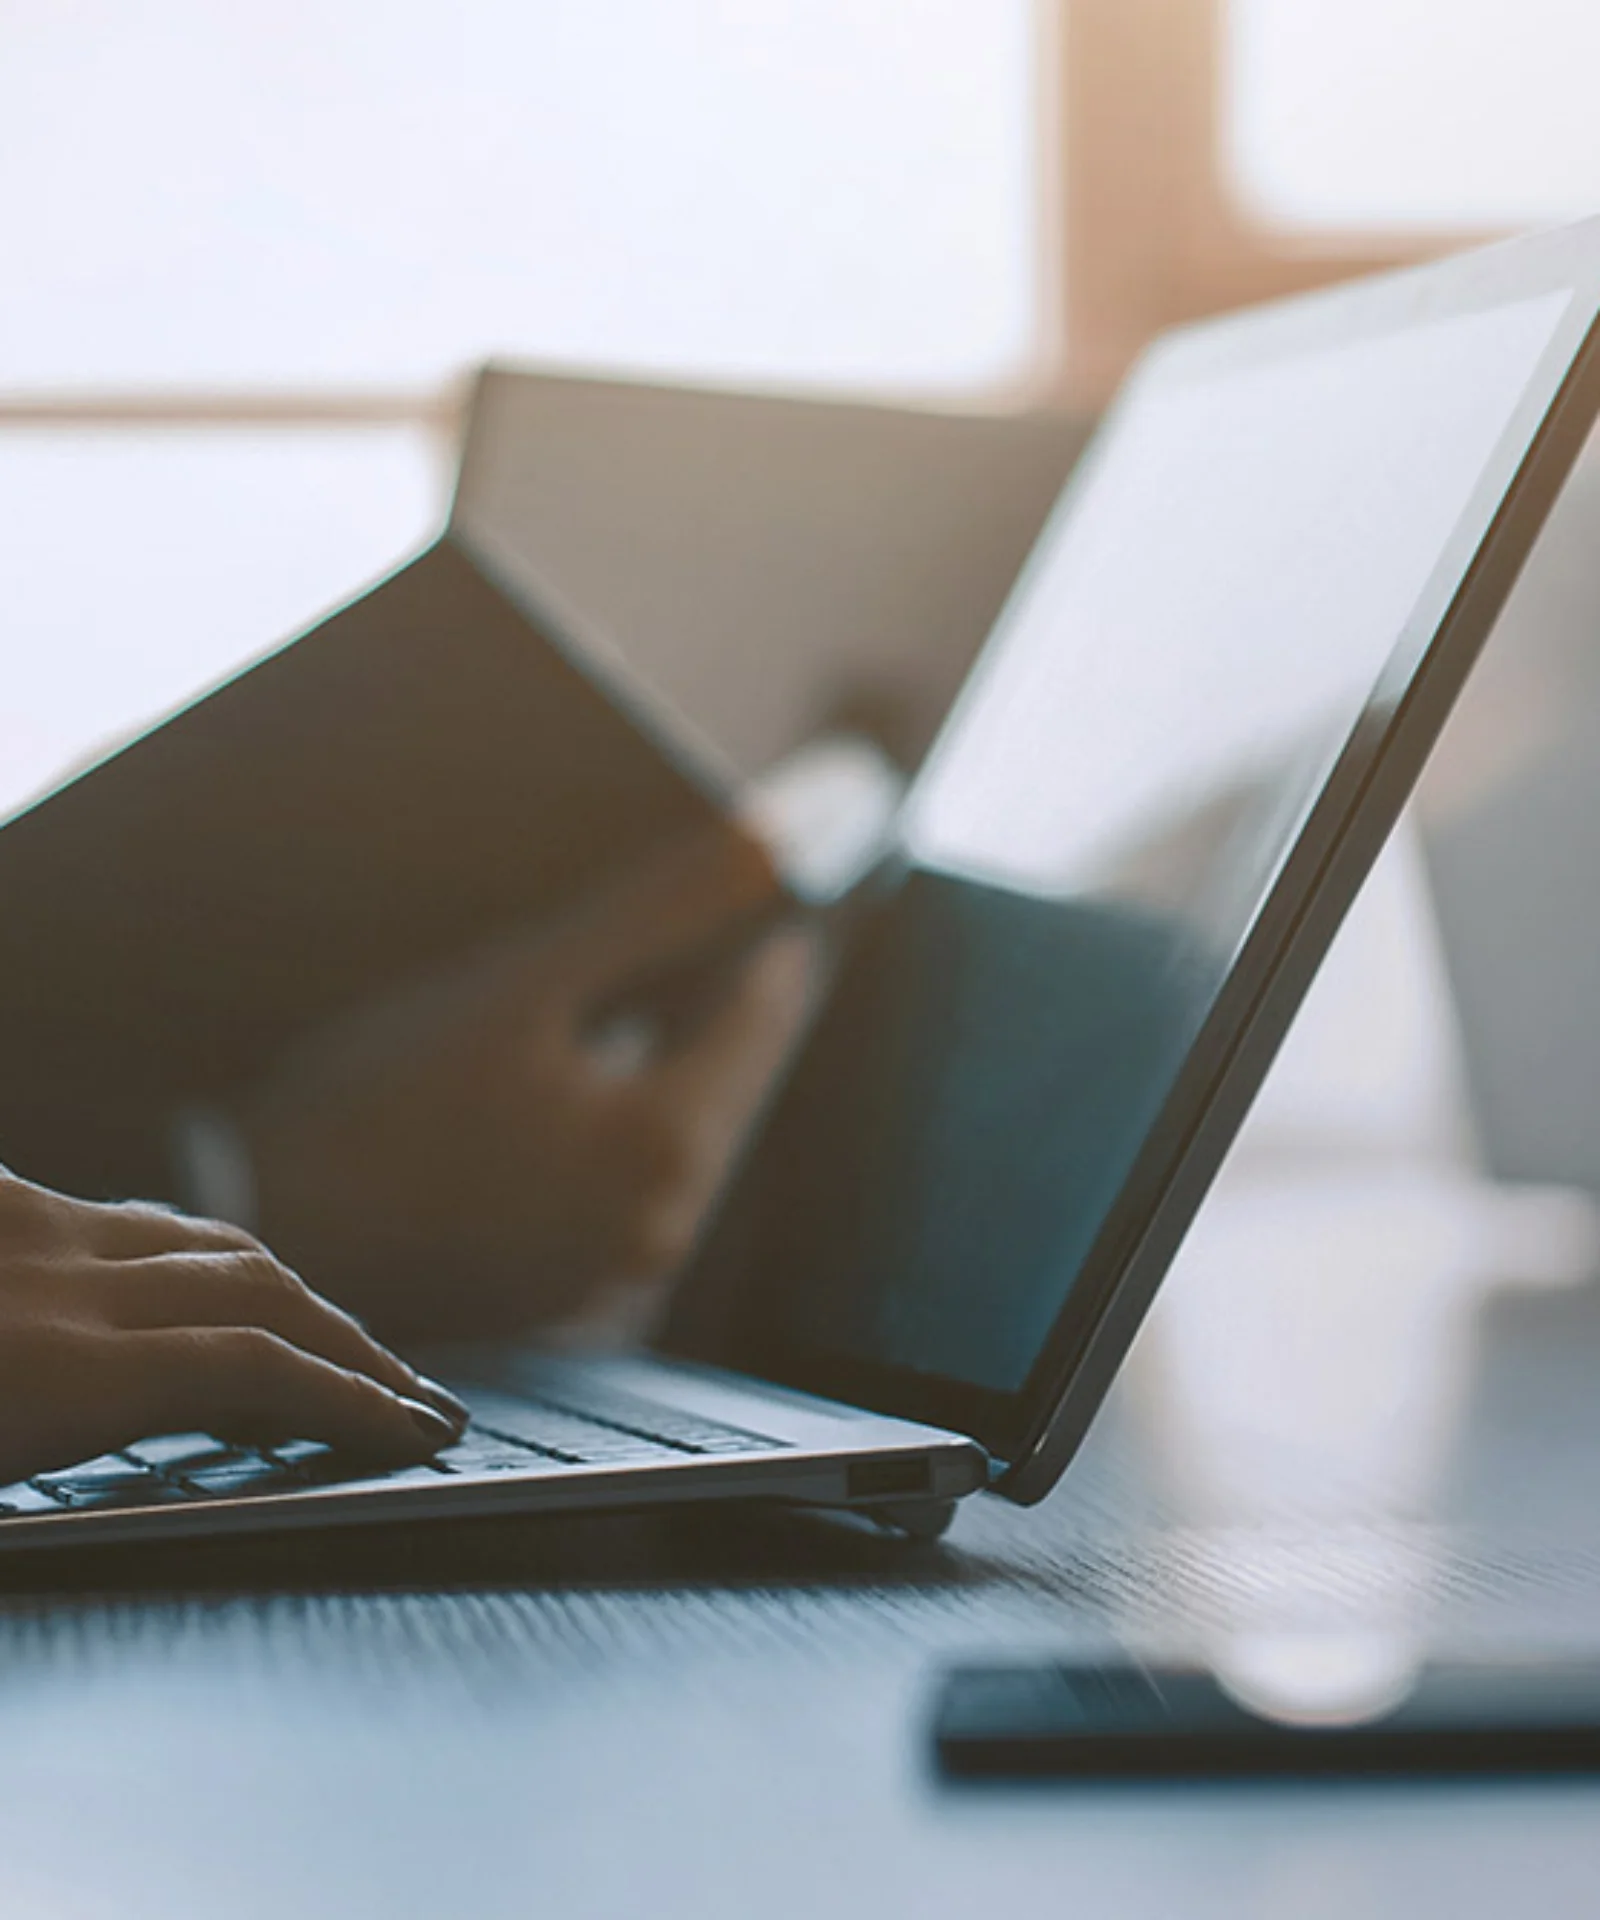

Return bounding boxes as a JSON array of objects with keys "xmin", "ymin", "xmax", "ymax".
[{"xmin": 1058, "ymin": 0, "xmax": 1536, "ymax": 405}]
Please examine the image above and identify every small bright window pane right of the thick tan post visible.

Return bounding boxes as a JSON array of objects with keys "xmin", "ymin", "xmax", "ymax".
[{"xmin": 1229, "ymin": 0, "xmax": 1600, "ymax": 228}]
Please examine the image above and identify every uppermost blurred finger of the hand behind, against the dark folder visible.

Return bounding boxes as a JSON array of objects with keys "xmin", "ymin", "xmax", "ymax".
[{"xmin": 540, "ymin": 824, "xmax": 784, "ymax": 1006}]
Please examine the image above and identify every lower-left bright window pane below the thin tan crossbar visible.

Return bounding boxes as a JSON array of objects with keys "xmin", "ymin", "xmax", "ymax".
[{"xmin": 0, "ymin": 428, "xmax": 440, "ymax": 812}]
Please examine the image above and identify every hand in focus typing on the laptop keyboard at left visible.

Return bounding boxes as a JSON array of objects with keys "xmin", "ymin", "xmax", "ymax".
[{"xmin": 0, "ymin": 1169, "xmax": 465, "ymax": 1484}]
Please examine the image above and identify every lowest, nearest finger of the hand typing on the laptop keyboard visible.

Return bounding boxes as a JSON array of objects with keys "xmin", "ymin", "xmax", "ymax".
[{"xmin": 98, "ymin": 1327, "xmax": 455, "ymax": 1461}]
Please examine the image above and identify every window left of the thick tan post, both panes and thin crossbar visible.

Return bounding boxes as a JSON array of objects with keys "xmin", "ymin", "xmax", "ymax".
[{"xmin": 0, "ymin": 0, "xmax": 1045, "ymax": 806}]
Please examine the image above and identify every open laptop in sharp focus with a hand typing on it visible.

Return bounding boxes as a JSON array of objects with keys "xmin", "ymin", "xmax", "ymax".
[{"xmin": 0, "ymin": 221, "xmax": 1600, "ymax": 1549}]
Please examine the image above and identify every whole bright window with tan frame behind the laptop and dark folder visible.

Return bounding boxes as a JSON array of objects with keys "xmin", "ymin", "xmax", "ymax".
[{"xmin": 12, "ymin": 0, "xmax": 1600, "ymax": 817}]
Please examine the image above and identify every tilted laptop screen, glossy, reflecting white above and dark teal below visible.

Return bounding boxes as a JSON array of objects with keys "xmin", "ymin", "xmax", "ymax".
[{"xmin": 670, "ymin": 243, "xmax": 1598, "ymax": 1466}]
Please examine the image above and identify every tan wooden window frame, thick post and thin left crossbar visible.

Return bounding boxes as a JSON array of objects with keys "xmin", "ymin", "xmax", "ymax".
[{"xmin": 0, "ymin": 0, "xmax": 1491, "ymax": 432}]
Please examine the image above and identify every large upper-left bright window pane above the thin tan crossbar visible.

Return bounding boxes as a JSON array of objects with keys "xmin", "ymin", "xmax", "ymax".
[{"xmin": 0, "ymin": 0, "xmax": 1037, "ymax": 390}]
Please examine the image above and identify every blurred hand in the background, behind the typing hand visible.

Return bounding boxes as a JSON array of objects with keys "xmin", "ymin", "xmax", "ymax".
[{"xmin": 238, "ymin": 828, "xmax": 818, "ymax": 1334}]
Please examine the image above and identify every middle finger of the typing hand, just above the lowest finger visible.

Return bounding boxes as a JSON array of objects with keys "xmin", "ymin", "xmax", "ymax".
[{"xmin": 104, "ymin": 1244, "xmax": 467, "ymax": 1428}]
